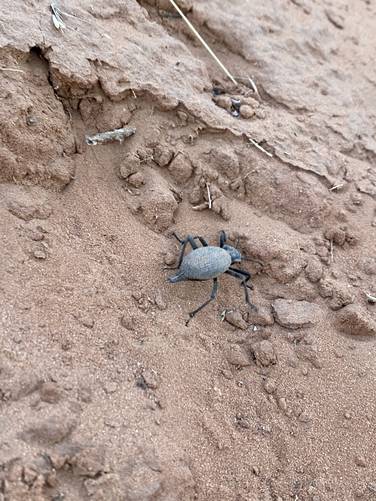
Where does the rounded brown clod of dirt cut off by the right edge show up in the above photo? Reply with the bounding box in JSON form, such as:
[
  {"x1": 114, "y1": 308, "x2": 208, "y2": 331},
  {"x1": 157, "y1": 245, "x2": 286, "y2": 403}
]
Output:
[{"x1": 335, "y1": 304, "x2": 376, "y2": 336}]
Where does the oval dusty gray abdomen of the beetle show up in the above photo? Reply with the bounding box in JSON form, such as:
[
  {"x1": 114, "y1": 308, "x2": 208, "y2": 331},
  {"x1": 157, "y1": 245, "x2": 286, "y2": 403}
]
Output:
[{"x1": 180, "y1": 246, "x2": 231, "y2": 280}]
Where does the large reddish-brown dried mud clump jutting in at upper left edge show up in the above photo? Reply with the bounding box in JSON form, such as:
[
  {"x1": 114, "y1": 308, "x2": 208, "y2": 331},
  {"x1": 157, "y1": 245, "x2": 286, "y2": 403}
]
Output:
[{"x1": 0, "y1": 55, "x2": 76, "y2": 189}]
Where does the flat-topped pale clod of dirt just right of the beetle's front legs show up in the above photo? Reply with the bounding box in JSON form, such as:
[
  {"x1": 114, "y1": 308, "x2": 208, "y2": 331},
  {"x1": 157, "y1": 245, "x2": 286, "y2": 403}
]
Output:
[{"x1": 272, "y1": 299, "x2": 321, "y2": 329}]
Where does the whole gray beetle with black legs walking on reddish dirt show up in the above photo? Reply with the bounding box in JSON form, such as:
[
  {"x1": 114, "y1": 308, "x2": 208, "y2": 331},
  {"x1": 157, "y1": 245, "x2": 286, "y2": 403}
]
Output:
[{"x1": 168, "y1": 231, "x2": 257, "y2": 325}]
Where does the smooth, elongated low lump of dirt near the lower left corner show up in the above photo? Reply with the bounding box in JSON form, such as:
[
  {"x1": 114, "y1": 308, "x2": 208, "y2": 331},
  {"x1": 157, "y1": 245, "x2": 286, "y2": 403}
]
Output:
[{"x1": 20, "y1": 412, "x2": 77, "y2": 444}]
